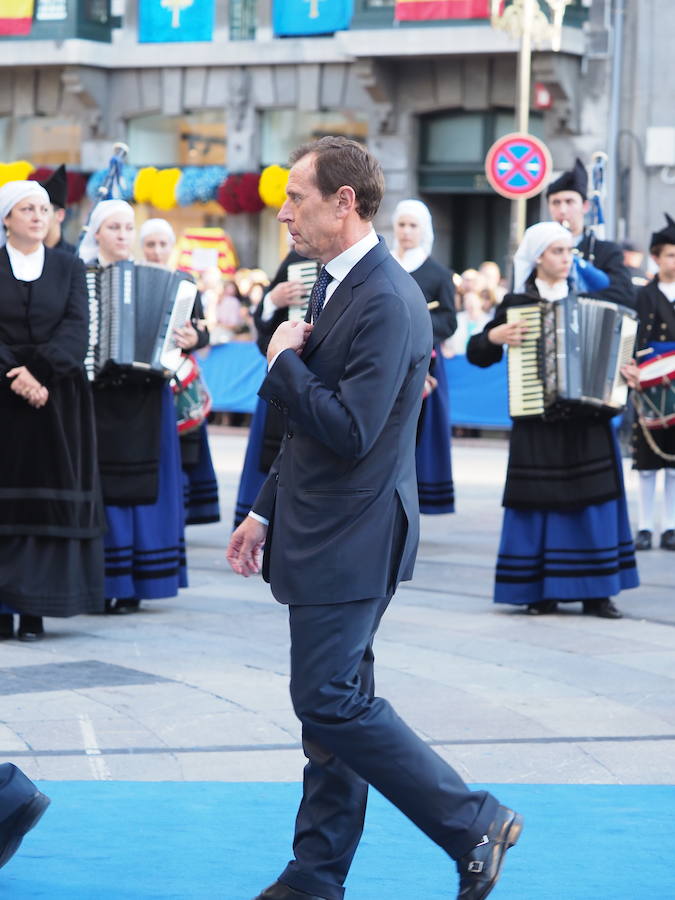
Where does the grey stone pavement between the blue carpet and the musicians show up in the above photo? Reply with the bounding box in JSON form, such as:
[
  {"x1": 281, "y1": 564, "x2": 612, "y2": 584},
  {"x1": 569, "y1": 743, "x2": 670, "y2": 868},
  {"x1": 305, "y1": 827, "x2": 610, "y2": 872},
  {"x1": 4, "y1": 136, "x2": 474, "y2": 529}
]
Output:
[{"x1": 0, "y1": 429, "x2": 675, "y2": 784}]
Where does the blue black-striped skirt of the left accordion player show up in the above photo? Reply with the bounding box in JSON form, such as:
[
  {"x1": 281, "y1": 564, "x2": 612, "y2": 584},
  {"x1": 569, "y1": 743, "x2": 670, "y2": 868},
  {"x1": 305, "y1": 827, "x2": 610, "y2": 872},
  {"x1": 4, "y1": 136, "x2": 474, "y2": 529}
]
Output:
[{"x1": 104, "y1": 385, "x2": 187, "y2": 600}]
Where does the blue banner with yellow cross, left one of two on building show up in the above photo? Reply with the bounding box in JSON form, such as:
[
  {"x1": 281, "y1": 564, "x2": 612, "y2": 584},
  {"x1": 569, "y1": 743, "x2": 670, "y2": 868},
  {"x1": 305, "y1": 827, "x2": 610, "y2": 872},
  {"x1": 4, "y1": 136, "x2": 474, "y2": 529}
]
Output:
[{"x1": 138, "y1": 0, "x2": 215, "y2": 44}]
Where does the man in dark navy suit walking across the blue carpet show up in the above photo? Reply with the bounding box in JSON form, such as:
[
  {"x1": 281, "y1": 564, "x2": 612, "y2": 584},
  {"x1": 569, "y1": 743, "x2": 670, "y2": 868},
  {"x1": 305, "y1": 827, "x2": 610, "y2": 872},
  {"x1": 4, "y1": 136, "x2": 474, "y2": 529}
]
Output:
[{"x1": 227, "y1": 137, "x2": 522, "y2": 900}]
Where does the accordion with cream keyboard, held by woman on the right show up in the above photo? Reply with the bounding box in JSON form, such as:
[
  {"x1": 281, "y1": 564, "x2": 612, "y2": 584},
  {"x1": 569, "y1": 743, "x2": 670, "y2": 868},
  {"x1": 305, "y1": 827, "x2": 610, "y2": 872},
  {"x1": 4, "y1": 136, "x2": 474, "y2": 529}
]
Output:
[{"x1": 506, "y1": 294, "x2": 638, "y2": 419}]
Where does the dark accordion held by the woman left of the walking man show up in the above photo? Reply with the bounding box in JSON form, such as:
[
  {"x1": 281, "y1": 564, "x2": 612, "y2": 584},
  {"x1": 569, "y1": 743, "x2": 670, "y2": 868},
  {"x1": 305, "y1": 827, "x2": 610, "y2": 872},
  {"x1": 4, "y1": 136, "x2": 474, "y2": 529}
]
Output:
[{"x1": 84, "y1": 260, "x2": 197, "y2": 381}]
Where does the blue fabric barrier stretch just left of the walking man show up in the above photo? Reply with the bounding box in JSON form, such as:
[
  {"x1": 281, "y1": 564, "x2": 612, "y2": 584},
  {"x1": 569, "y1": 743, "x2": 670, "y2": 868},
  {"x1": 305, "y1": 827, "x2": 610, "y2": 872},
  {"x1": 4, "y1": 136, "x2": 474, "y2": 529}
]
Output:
[{"x1": 199, "y1": 341, "x2": 267, "y2": 413}]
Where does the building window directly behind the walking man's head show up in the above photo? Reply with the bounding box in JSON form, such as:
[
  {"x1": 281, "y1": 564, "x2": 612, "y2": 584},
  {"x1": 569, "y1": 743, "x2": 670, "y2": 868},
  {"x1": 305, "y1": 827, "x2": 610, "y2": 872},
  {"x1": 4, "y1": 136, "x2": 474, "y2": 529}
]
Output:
[{"x1": 260, "y1": 109, "x2": 368, "y2": 166}]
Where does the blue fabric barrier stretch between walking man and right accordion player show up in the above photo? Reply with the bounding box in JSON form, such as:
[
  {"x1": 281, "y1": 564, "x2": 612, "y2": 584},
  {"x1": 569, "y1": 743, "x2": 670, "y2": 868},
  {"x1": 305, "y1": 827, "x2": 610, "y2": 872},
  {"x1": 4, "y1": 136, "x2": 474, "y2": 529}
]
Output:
[{"x1": 443, "y1": 356, "x2": 511, "y2": 428}]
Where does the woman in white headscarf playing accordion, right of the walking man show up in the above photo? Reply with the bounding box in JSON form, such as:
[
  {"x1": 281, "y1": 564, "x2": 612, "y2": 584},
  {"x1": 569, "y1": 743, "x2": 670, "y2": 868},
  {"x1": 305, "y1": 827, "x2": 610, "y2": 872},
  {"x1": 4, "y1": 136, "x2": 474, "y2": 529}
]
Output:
[{"x1": 467, "y1": 222, "x2": 639, "y2": 619}]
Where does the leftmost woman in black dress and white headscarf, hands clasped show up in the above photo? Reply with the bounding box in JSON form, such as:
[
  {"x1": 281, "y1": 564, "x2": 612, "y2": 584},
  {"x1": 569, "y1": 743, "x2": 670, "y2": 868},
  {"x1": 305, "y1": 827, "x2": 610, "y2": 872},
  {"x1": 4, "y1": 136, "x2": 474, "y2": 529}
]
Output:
[{"x1": 0, "y1": 181, "x2": 104, "y2": 641}]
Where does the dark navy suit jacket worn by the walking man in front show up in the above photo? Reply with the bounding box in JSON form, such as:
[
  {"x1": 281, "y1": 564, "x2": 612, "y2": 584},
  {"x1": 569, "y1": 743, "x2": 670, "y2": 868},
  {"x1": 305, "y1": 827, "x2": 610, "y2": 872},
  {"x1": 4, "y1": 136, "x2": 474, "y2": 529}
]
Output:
[{"x1": 253, "y1": 240, "x2": 432, "y2": 604}]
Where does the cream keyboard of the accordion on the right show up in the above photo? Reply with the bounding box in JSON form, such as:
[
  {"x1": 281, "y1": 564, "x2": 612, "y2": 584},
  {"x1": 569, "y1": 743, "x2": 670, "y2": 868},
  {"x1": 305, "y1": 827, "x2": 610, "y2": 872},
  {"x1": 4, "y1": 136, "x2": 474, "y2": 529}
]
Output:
[{"x1": 506, "y1": 303, "x2": 545, "y2": 418}]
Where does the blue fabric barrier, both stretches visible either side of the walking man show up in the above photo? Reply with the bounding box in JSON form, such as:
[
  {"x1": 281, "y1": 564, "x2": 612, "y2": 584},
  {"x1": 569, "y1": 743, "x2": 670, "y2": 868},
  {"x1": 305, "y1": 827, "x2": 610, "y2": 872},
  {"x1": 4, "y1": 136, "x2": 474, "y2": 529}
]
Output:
[{"x1": 199, "y1": 342, "x2": 511, "y2": 428}]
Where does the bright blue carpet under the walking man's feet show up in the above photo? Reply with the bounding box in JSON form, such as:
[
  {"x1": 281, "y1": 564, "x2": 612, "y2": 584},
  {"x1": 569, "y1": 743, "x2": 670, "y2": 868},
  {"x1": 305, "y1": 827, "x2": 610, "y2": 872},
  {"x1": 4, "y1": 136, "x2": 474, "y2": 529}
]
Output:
[{"x1": 5, "y1": 782, "x2": 675, "y2": 900}]
